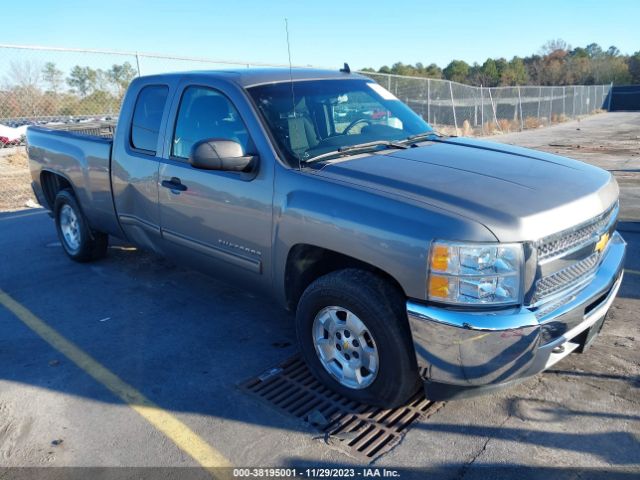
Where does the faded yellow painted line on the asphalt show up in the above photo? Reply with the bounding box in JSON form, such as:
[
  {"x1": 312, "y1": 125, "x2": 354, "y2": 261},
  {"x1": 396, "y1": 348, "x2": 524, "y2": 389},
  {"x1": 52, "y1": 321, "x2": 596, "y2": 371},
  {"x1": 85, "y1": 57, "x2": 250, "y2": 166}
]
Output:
[{"x1": 0, "y1": 290, "x2": 231, "y2": 468}]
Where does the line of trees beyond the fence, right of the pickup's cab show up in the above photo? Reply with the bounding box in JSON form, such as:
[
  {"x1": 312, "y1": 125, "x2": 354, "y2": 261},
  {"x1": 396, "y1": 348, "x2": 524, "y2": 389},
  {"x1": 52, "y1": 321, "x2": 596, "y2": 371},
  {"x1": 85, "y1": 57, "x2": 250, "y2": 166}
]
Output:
[{"x1": 363, "y1": 40, "x2": 640, "y2": 87}]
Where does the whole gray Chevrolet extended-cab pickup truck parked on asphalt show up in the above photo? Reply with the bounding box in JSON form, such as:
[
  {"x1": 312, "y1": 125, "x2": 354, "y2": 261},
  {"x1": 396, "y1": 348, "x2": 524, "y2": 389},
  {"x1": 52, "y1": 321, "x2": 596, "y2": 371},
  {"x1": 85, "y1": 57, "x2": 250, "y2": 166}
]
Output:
[{"x1": 27, "y1": 69, "x2": 625, "y2": 407}]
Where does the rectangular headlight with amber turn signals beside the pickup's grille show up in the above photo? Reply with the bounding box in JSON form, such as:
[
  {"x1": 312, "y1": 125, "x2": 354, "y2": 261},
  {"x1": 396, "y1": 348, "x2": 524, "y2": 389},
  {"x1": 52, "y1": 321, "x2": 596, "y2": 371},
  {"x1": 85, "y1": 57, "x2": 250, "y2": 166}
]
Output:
[{"x1": 427, "y1": 241, "x2": 524, "y2": 305}]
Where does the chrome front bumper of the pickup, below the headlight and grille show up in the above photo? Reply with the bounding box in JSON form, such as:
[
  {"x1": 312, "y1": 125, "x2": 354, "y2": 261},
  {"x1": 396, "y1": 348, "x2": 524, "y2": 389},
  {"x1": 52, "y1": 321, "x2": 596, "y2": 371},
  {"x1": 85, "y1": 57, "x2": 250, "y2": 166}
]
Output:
[{"x1": 407, "y1": 232, "x2": 626, "y2": 387}]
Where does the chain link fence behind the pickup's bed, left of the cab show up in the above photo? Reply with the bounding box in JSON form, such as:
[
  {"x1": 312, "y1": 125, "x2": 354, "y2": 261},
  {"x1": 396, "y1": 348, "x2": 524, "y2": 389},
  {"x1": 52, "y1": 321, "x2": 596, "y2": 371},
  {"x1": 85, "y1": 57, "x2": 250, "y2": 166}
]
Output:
[{"x1": 0, "y1": 45, "x2": 286, "y2": 212}]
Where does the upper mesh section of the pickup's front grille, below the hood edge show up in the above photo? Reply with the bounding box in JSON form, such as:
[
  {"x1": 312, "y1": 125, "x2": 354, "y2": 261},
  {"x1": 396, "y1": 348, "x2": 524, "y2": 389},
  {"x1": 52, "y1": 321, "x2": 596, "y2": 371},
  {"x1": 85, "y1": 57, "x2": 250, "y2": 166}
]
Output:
[{"x1": 536, "y1": 202, "x2": 618, "y2": 262}]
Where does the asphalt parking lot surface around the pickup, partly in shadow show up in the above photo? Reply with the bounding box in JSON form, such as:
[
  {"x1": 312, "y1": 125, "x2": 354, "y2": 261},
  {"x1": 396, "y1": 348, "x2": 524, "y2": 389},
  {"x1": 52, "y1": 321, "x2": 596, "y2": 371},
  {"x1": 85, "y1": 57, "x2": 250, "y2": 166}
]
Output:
[{"x1": 0, "y1": 113, "x2": 640, "y2": 479}]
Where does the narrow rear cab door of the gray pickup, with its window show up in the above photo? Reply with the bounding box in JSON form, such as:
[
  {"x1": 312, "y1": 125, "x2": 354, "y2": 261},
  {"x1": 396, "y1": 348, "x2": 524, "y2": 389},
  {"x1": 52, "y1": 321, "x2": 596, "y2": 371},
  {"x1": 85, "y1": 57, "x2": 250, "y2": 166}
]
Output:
[{"x1": 111, "y1": 81, "x2": 170, "y2": 250}]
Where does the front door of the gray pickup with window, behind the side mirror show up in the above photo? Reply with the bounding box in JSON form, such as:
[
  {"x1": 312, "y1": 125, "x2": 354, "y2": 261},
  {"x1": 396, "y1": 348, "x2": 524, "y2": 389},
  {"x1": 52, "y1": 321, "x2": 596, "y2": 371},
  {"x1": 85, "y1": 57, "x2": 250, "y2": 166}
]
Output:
[{"x1": 159, "y1": 80, "x2": 273, "y2": 287}]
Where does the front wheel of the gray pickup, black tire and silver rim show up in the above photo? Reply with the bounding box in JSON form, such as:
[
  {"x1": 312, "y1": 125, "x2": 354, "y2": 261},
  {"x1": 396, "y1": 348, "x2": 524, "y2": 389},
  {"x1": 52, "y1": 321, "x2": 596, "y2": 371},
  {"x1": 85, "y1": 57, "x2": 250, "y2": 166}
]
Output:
[{"x1": 296, "y1": 269, "x2": 420, "y2": 408}]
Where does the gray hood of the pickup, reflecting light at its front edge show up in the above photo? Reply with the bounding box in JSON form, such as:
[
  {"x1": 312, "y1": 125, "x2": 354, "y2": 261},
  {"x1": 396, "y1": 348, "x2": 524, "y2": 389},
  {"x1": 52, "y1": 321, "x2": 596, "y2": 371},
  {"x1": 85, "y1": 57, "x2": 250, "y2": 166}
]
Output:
[{"x1": 318, "y1": 138, "x2": 618, "y2": 242}]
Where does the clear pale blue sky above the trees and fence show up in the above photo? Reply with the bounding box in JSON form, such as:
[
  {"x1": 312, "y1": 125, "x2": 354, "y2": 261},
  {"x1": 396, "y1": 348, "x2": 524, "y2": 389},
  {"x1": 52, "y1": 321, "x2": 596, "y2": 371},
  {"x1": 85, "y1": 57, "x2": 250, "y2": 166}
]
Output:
[{"x1": 0, "y1": 0, "x2": 640, "y2": 69}]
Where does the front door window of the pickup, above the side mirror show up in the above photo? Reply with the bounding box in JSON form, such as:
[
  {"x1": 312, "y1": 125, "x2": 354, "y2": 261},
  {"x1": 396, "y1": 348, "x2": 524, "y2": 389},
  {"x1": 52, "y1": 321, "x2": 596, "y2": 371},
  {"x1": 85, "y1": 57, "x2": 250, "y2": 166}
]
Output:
[{"x1": 171, "y1": 87, "x2": 253, "y2": 158}]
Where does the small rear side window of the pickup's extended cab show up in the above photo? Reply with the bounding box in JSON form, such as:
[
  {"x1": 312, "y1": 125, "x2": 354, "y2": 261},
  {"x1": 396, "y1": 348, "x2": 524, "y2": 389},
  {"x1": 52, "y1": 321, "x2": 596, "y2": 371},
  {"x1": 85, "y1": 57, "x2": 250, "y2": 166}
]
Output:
[{"x1": 131, "y1": 85, "x2": 169, "y2": 155}]
